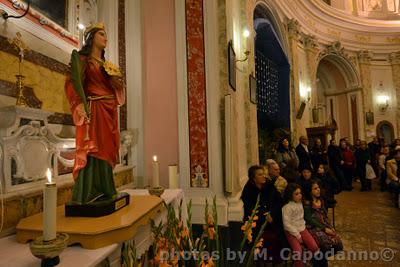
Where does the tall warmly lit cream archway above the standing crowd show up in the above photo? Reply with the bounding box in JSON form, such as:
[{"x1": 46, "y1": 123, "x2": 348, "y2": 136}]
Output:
[{"x1": 316, "y1": 52, "x2": 362, "y2": 142}]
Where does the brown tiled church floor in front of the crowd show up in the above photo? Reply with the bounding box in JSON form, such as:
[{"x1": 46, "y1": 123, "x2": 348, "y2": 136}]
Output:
[{"x1": 329, "y1": 181, "x2": 400, "y2": 267}]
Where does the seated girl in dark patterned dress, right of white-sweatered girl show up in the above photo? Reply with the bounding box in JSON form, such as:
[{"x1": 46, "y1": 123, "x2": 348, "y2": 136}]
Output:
[{"x1": 304, "y1": 180, "x2": 343, "y2": 254}]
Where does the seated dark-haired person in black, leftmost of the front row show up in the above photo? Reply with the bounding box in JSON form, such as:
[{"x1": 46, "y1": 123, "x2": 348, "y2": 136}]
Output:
[{"x1": 241, "y1": 165, "x2": 286, "y2": 263}]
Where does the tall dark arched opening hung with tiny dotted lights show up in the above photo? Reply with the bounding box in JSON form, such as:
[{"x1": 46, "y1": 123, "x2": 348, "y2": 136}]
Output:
[{"x1": 253, "y1": 4, "x2": 290, "y2": 163}]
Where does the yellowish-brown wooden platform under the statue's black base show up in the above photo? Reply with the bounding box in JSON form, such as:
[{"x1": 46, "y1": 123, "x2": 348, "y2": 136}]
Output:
[{"x1": 17, "y1": 195, "x2": 165, "y2": 249}]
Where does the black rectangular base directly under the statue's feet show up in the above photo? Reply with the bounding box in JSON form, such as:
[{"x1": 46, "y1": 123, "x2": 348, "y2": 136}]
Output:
[{"x1": 65, "y1": 192, "x2": 129, "y2": 217}]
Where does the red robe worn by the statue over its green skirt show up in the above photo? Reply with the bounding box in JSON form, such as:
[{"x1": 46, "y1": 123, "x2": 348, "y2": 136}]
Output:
[{"x1": 65, "y1": 56, "x2": 125, "y2": 179}]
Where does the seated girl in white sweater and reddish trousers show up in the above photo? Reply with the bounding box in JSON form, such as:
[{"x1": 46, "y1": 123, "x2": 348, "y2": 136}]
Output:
[{"x1": 282, "y1": 183, "x2": 319, "y2": 267}]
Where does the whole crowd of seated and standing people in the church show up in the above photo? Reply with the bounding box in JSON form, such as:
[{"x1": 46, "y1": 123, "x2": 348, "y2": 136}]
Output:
[{"x1": 241, "y1": 136, "x2": 400, "y2": 266}]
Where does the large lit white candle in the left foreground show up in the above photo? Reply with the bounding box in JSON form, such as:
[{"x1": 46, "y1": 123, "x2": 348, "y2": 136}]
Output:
[{"x1": 43, "y1": 169, "x2": 57, "y2": 241}]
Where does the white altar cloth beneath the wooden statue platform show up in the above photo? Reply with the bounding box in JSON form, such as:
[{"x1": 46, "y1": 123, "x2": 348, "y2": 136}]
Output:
[{"x1": 0, "y1": 189, "x2": 187, "y2": 267}]
